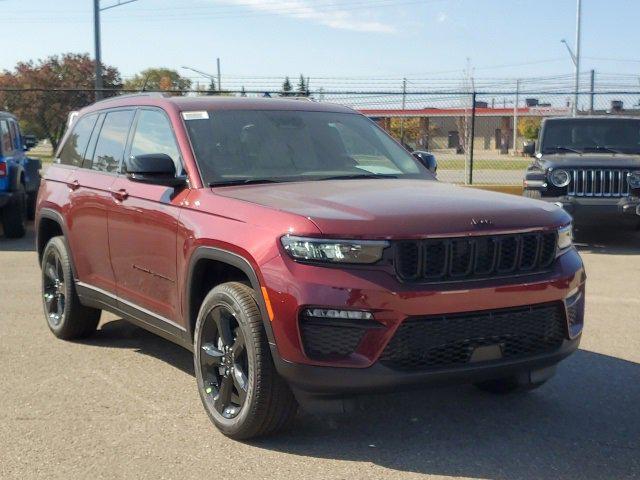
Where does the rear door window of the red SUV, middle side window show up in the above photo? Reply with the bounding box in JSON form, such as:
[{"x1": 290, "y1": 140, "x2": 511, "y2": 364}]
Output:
[{"x1": 88, "y1": 110, "x2": 134, "y2": 172}]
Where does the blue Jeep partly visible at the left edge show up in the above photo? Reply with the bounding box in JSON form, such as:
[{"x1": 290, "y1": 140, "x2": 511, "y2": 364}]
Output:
[{"x1": 0, "y1": 112, "x2": 42, "y2": 238}]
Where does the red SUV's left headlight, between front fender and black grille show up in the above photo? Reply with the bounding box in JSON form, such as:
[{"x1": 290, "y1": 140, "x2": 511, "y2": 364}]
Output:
[{"x1": 281, "y1": 235, "x2": 389, "y2": 263}]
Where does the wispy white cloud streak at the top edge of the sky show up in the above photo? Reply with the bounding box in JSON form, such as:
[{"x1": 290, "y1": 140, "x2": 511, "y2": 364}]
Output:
[{"x1": 215, "y1": 0, "x2": 395, "y2": 33}]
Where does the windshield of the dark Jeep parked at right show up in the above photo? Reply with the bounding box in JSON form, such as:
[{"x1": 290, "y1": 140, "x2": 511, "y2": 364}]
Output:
[{"x1": 541, "y1": 118, "x2": 640, "y2": 153}]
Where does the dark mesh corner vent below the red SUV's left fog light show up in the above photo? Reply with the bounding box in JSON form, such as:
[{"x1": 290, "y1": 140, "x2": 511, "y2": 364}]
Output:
[{"x1": 300, "y1": 316, "x2": 366, "y2": 360}]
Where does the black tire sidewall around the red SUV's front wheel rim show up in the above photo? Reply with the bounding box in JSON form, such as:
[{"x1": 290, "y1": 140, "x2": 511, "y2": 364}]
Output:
[{"x1": 194, "y1": 289, "x2": 260, "y2": 435}]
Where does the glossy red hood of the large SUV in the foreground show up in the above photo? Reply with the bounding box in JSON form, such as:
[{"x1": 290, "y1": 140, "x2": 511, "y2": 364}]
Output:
[{"x1": 214, "y1": 179, "x2": 571, "y2": 238}]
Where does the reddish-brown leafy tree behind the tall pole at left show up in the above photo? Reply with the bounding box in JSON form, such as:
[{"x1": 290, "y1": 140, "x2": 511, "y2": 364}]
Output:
[{"x1": 0, "y1": 53, "x2": 122, "y2": 149}]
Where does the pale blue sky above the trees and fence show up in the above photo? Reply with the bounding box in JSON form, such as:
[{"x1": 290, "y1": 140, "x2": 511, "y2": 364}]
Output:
[{"x1": 0, "y1": 0, "x2": 640, "y2": 87}]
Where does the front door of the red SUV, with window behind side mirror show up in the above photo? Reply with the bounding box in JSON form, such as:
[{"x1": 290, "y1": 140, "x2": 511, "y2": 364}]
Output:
[{"x1": 109, "y1": 107, "x2": 188, "y2": 329}]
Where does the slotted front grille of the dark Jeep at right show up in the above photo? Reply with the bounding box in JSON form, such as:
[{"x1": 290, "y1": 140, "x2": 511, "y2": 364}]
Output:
[{"x1": 567, "y1": 169, "x2": 629, "y2": 197}]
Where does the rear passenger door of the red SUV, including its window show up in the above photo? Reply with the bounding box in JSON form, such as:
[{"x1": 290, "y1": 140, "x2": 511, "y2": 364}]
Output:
[{"x1": 66, "y1": 109, "x2": 135, "y2": 295}]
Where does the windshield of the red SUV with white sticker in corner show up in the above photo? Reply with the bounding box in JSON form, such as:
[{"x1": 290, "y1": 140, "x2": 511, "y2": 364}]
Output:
[{"x1": 183, "y1": 110, "x2": 433, "y2": 185}]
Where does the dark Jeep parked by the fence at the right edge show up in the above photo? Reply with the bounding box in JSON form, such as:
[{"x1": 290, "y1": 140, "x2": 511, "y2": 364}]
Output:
[{"x1": 524, "y1": 116, "x2": 640, "y2": 226}]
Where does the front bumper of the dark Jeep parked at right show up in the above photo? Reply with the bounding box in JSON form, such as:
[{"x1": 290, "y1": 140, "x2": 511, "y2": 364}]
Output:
[{"x1": 542, "y1": 196, "x2": 640, "y2": 223}]
